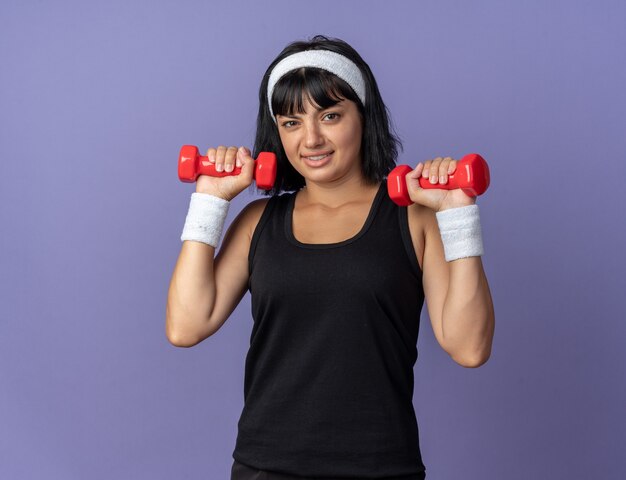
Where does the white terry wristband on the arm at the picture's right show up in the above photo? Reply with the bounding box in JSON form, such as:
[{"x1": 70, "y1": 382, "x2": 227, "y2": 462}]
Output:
[{"x1": 436, "y1": 204, "x2": 484, "y2": 262}]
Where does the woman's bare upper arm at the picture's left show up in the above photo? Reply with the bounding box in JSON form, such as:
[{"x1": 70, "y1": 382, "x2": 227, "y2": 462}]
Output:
[{"x1": 205, "y1": 198, "x2": 269, "y2": 338}]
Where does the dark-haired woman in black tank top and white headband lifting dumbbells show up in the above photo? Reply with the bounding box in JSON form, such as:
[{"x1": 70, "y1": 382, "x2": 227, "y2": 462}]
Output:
[{"x1": 166, "y1": 36, "x2": 494, "y2": 480}]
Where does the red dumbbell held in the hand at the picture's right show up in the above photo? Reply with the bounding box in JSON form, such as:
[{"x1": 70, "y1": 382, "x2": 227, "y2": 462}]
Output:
[{"x1": 387, "y1": 153, "x2": 489, "y2": 206}]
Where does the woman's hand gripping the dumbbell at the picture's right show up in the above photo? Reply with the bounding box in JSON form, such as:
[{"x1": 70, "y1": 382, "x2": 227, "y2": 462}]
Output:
[{"x1": 406, "y1": 157, "x2": 476, "y2": 212}]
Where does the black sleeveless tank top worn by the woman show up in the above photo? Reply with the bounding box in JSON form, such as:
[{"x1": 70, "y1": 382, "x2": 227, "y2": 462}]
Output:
[{"x1": 233, "y1": 182, "x2": 425, "y2": 480}]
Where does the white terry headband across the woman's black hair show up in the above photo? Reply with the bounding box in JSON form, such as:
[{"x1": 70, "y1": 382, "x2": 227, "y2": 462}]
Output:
[{"x1": 267, "y1": 50, "x2": 365, "y2": 123}]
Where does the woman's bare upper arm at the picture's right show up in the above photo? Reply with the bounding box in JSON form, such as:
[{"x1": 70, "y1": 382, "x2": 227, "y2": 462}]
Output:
[{"x1": 408, "y1": 204, "x2": 450, "y2": 352}]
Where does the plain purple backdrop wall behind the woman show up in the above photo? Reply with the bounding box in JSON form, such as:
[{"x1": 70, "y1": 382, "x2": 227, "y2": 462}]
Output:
[{"x1": 0, "y1": 0, "x2": 626, "y2": 480}]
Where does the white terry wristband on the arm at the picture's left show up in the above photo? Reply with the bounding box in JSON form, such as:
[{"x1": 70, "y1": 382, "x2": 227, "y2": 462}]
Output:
[{"x1": 180, "y1": 192, "x2": 230, "y2": 247}]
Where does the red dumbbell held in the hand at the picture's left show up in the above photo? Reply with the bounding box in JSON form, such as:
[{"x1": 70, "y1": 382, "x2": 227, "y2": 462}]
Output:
[{"x1": 178, "y1": 145, "x2": 276, "y2": 190}]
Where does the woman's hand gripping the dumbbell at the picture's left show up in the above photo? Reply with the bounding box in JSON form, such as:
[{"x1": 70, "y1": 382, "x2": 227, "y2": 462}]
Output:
[{"x1": 196, "y1": 145, "x2": 255, "y2": 201}]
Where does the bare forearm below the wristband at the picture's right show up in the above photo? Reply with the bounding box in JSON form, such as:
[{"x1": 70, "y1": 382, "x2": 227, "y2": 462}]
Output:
[{"x1": 442, "y1": 256, "x2": 495, "y2": 366}]
